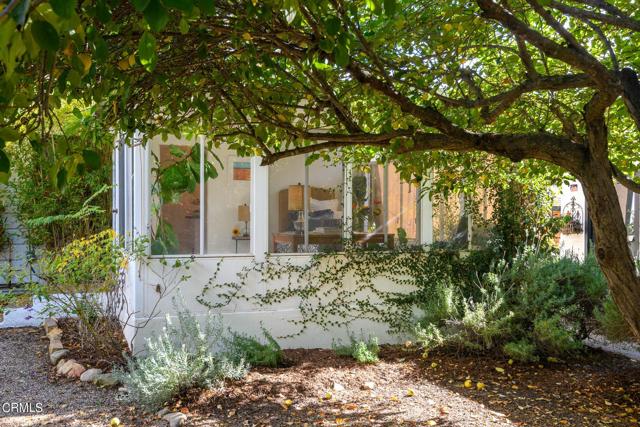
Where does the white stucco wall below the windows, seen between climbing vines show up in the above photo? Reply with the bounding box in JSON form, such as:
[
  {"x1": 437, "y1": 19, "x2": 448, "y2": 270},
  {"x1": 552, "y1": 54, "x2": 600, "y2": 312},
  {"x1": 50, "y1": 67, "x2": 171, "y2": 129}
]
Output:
[{"x1": 126, "y1": 256, "x2": 410, "y2": 352}]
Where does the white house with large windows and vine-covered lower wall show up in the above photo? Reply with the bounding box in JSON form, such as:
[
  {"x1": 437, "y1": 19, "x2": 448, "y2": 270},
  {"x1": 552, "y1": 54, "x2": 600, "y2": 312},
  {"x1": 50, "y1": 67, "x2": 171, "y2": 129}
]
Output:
[{"x1": 113, "y1": 137, "x2": 432, "y2": 351}]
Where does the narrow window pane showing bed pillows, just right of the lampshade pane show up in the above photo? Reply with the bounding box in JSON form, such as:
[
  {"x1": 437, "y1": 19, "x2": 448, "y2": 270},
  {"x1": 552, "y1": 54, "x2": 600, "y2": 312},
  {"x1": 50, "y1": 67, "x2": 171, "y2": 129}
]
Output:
[{"x1": 306, "y1": 160, "x2": 344, "y2": 252}]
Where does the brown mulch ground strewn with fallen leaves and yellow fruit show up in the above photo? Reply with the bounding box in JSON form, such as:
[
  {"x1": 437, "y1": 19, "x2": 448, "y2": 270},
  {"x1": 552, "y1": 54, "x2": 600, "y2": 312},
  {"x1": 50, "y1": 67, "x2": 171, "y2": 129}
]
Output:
[{"x1": 176, "y1": 346, "x2": 640, "y2": 427}]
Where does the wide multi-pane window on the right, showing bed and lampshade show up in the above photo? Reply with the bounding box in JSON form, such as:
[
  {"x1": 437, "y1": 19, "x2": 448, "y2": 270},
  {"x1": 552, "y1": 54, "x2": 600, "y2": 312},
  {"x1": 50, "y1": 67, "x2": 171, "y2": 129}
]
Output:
[{"x1": 269, "y1": 156, "x2": 419, "y2": 253}]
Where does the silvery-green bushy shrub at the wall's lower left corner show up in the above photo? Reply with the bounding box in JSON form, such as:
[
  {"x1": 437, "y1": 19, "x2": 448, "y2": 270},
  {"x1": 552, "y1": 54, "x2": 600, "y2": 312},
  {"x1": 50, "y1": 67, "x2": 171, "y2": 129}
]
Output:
[{"x1": 117, "y1": 300, "x2": 247, "y2": 410}]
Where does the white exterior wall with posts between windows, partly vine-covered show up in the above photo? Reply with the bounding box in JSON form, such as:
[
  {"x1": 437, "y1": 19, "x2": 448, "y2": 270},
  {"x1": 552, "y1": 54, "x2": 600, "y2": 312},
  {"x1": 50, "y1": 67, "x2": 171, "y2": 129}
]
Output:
[{"x1": 114, "y1": 135, "x2": 432, "y2": 352}]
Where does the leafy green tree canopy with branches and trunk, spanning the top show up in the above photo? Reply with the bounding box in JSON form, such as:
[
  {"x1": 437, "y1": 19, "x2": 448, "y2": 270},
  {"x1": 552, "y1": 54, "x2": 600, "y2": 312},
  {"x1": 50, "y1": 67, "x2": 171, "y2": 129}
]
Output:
[{"x1": 0, "y1": 0, "x2": 640, "y2": 336}]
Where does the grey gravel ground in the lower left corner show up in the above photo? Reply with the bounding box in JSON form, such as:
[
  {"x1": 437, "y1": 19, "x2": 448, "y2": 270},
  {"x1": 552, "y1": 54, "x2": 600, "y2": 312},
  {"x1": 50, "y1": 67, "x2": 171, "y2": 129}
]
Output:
[{"x1": 0, "y1": 328, "x2": 157, "y2": 427}]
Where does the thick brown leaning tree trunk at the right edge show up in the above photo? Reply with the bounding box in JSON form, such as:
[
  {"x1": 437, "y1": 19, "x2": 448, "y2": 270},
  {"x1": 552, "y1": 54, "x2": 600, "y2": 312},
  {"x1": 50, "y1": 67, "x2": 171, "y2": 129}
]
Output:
[{"x1": 580, "y1": 161, "x2": 640, "y2": 339}]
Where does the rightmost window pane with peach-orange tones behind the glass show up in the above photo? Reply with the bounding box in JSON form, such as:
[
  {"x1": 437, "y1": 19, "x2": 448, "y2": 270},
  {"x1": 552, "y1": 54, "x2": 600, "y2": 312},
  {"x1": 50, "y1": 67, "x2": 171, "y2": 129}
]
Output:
[{"x1": 387, "y1": 165, "x2": 419, "y2": 245}]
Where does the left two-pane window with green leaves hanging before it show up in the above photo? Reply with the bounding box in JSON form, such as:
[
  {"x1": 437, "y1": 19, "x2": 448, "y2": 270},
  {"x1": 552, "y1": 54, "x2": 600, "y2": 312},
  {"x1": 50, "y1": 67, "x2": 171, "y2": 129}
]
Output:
[{"x1": 151, "y1": 138, "x2": 251, "y2": 255}]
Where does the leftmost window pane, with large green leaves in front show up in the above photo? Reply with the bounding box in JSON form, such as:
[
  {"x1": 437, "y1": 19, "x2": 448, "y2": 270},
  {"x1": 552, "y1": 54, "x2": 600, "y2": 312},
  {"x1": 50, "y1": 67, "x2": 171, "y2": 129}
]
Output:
[{"x1": 151, "y1": 137, "x2": 200, "y2": 255}]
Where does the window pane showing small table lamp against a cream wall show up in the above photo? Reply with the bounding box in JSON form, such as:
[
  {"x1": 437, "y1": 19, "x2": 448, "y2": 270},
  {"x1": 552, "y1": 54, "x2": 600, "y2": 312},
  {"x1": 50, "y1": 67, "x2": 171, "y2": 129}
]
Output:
[{"x1": 205, "y1": 148, "x2": 251, "y2": 254}]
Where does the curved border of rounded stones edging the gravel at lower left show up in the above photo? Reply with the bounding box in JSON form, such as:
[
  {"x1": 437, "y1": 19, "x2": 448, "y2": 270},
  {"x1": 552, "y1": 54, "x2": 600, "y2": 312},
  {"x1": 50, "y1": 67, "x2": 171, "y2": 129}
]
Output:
[{"x1": 42, "y1": 317, "x2": 187, "y2": 427}]
